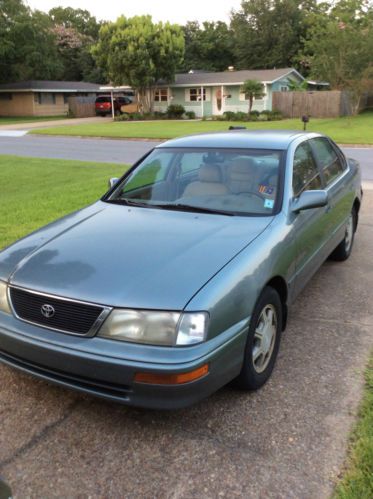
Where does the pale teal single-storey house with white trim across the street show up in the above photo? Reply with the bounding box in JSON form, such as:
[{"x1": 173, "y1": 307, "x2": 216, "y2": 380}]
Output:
[{"x1": 153, "y1": 68, "x2": 304, "y2": 117}]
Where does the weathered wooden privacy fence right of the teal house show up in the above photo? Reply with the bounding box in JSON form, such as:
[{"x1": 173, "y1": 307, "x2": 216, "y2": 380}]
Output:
[{"x1": 272, "y1": 90, "x2": 342, "y2": 118}]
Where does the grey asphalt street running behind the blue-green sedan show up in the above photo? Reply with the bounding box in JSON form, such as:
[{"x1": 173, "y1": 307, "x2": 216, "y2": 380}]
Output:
[{"x1": 0, "y1": 135, "x2": 373, "y2": 181}]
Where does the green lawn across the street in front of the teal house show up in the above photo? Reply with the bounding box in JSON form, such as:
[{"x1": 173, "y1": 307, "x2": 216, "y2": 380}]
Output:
[{"x1": 31, "y1": 113, "x2": 373, "y2": 144}]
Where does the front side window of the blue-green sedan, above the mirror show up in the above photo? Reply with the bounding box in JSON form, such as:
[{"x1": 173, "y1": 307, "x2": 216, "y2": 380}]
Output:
[{"x1": 293, "y1": 142, "x2": 322, "y2": 196}]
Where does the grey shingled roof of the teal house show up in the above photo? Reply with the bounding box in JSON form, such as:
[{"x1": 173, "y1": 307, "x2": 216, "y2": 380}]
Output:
[{"x1": 162, "y1": 68, "x2": 302, "y2": 86}]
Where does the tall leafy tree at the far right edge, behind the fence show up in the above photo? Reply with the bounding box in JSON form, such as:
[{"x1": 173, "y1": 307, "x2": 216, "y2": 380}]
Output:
[{"x1": 299, "y1": 0, "x2": 373, "y2": 113}]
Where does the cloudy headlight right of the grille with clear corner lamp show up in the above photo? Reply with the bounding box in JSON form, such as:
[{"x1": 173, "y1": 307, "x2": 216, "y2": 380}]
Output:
[{"x1": 98, "y1": 309, "x2": 208, "y2": 346}]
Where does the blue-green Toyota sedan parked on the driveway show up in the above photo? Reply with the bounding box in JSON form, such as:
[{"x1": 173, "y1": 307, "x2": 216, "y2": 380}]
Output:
[{"x1": 0, "y1": 130, "x2": 362, "y2": 408}]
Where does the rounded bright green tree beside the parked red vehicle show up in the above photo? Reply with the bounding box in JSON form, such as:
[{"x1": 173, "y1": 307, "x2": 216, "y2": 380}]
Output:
[{"x1": 92, "y1": 16, "x2": 184, "y2": 111}]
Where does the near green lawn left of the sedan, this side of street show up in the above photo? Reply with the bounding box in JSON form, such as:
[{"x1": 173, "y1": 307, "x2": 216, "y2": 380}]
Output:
[{"x1": 0, "y1": 156, "x2": 126, "y2": 248}]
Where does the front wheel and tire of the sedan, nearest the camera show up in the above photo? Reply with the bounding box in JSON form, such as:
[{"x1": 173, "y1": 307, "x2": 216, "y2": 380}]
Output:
[{"x1": 235, "y1": 286, "x2": 283, "y2": 390}]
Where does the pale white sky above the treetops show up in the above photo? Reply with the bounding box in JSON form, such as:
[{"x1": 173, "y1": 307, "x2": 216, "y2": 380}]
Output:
[{"x1": 25, "y1": 0, "x2": 241, "y2": 24}]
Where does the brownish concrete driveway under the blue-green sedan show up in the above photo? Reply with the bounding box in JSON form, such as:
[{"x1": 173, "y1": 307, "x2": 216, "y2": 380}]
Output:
[{"x1": 0, "y1": 189, "x2": 373, "y2": 499}]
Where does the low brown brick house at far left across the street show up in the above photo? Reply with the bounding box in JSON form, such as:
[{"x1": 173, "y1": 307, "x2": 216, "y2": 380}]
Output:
[{"x1": 0, "y1": 80, "x2": 101, "y2": 116}]
